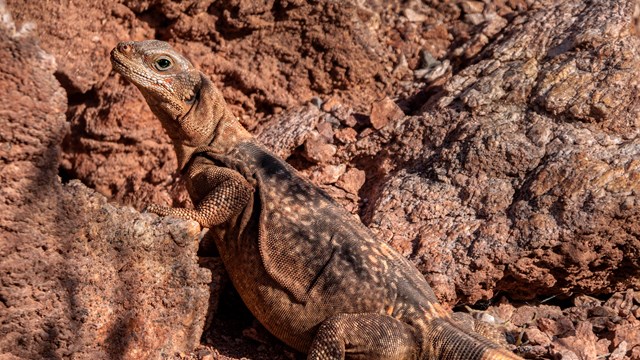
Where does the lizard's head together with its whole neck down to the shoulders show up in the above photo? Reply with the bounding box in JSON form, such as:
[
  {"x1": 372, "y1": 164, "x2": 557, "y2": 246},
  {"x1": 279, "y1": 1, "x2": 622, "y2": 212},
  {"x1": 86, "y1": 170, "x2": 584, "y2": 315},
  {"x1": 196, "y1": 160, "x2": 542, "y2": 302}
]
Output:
[{"x1": 110, "y1": 40, "x2": 251, "y2": 169}]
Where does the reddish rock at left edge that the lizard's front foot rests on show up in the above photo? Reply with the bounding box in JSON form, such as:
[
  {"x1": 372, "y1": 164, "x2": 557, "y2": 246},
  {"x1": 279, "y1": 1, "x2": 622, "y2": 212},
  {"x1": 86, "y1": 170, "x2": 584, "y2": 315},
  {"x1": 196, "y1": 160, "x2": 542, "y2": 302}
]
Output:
[{"x1": 0, "y1": 8, "x2": 211, "y2": 359}]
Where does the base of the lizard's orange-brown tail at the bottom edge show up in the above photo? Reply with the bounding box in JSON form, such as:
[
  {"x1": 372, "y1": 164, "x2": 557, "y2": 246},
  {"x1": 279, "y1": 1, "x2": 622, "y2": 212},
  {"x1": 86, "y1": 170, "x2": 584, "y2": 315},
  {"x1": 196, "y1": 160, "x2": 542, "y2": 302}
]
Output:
[{"x1": 423, "y1": 318, "x2": 522, "y2": 360}]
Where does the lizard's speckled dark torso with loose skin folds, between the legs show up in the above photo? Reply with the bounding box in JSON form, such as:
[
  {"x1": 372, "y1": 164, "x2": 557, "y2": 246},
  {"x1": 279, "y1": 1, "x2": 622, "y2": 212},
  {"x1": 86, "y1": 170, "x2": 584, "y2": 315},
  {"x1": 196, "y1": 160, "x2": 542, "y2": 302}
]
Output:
[{"x1": 201, "y1": 142, "x2": 437, "y2": 351}]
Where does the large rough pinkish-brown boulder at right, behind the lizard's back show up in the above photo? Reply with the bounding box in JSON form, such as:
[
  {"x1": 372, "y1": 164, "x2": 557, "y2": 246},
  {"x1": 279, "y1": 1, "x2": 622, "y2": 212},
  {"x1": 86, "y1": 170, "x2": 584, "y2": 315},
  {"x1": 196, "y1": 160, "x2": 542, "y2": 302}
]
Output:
[{"x1": 366, "y1": 1, "x2": 640, "y2": 302}]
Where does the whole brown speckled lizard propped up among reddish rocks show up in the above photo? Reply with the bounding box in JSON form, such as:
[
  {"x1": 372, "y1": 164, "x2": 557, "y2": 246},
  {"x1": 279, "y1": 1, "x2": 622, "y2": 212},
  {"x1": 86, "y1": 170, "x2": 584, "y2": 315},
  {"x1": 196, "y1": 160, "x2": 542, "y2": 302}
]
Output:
[{"x1": 111, "y1": 40, "x2": 521, "y2": 360}]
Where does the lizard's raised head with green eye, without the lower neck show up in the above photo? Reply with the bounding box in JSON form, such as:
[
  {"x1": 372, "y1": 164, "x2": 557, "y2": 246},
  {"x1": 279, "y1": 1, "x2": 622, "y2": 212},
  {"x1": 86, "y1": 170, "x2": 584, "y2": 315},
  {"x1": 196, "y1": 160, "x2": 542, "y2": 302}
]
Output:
[{"x1": 111, "y1": 40, "x2": 224, "y2": 147}]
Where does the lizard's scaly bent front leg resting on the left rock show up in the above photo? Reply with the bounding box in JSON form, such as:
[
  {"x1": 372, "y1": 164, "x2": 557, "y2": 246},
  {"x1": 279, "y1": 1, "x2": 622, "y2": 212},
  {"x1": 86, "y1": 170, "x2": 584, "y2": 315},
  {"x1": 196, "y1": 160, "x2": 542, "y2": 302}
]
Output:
[{"x1": 147, "y1": 164, "x2": 253, "y2": 228}]
